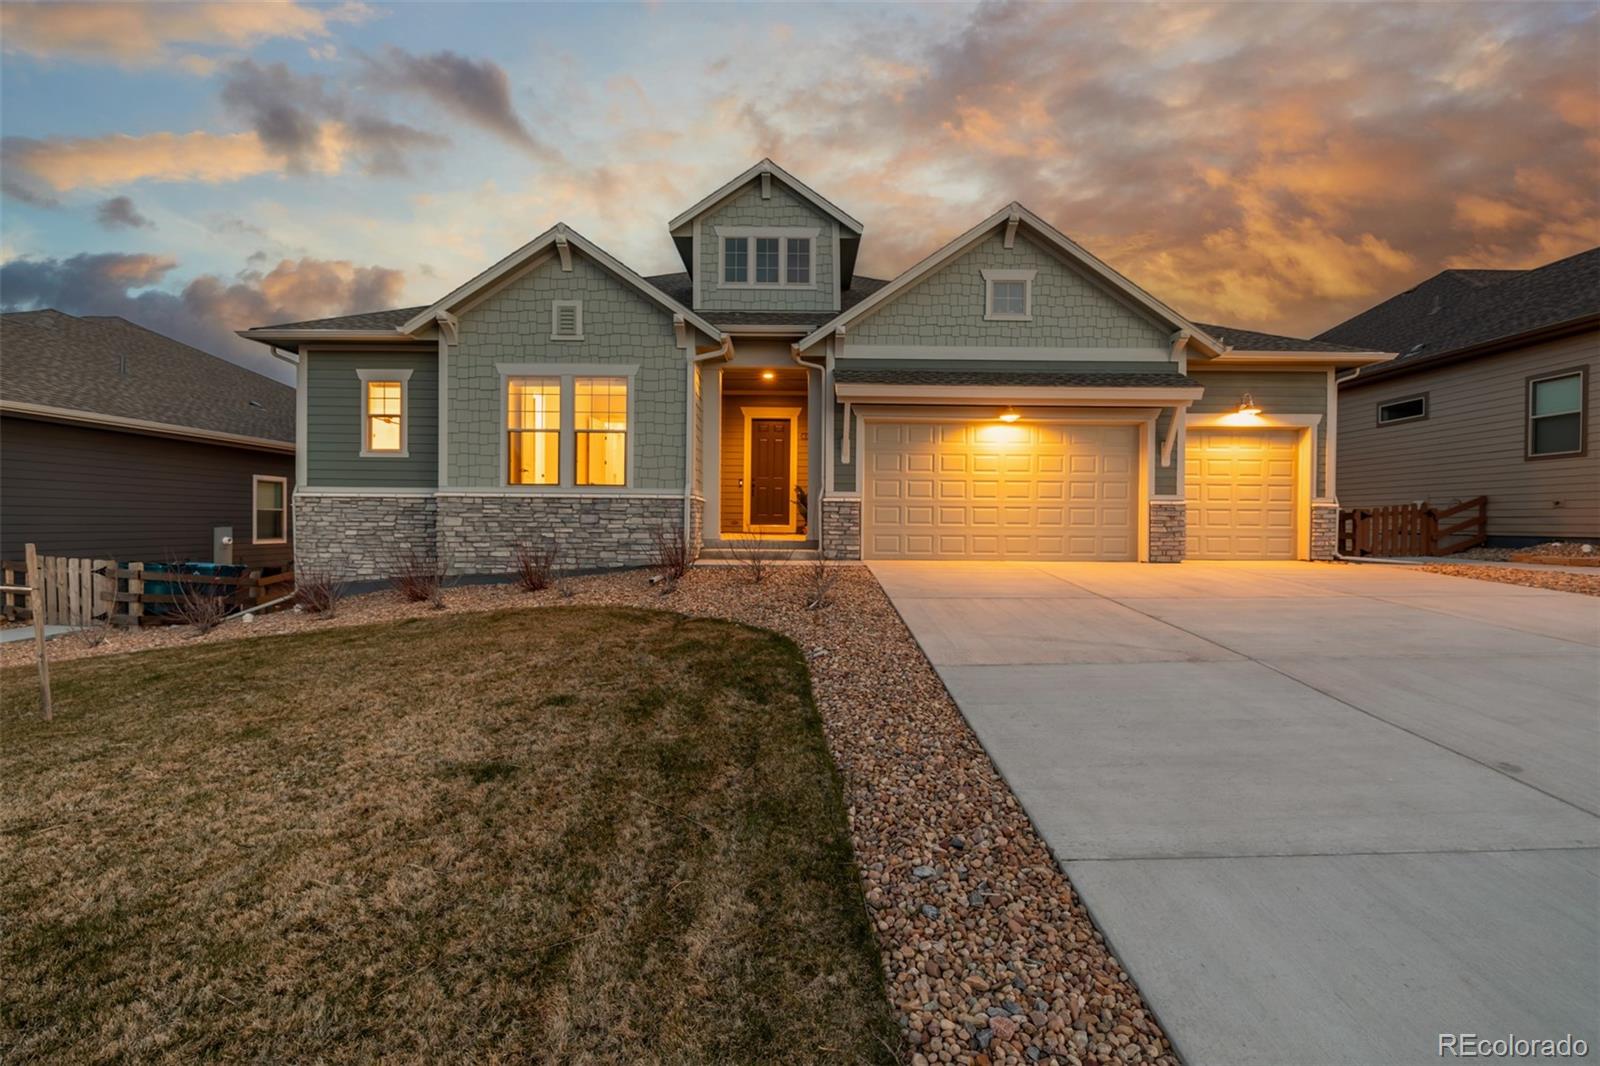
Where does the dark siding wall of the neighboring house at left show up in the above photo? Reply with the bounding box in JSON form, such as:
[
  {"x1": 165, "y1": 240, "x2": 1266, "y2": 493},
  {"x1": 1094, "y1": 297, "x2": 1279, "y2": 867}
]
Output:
[{"x1": 0, "y1": 416, "x2": 294, "y2": 567}]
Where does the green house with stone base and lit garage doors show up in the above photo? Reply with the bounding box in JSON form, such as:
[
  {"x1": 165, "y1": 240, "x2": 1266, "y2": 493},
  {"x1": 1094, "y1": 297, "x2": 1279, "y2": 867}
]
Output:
[{"x1": 242, "y1": 160, "x2": 1387, "y2": 578}]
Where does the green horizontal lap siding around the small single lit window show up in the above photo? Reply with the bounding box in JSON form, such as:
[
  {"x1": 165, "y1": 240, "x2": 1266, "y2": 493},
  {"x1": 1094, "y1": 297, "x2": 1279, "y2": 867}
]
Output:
[{"x1": 306, "y1": 351, "x2": 438, "y2": 488}]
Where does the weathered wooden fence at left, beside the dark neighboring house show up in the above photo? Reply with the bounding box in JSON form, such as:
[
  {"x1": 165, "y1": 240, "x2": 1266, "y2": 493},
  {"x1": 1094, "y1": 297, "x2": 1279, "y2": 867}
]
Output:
[{"x1": 0, "y1": 555, "x2": 294, "y2": 626}]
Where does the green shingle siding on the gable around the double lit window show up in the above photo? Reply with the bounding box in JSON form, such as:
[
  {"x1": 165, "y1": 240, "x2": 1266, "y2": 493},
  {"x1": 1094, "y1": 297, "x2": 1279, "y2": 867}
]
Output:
[{"x1": 448, "y1": 248, "x2": 688, "y2": 491}]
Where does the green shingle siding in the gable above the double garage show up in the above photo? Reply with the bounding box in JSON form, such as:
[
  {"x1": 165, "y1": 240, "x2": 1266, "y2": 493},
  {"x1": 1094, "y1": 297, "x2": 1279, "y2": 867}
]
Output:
[{"x1": 850, "y1": 230, "x2": 1173, "y2": 347}]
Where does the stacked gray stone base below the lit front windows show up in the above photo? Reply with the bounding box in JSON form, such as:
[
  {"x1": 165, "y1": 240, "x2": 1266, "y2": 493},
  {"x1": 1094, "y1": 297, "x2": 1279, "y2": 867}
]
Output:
[{"x1": 294, "y1": 493, "x2": 699, "y2": 581}]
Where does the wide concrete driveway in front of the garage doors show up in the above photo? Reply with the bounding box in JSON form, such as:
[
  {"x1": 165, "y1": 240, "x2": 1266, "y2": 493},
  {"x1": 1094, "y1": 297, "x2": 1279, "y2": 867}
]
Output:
[{"x1": 872, "y1": 562, "x2": 1600, "y2": 1066}]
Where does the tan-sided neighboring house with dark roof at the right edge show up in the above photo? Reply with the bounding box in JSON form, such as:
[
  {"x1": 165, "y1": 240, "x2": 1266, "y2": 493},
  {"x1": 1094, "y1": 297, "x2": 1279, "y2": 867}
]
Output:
[{"x1": 1318, "y1": 248, "x2": 1600, "y2": 544}]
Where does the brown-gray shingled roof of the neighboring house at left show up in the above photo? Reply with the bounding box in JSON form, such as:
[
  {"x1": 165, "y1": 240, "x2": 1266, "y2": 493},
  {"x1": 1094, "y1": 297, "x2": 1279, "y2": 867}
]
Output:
[{"x1": 0, "y1": 309, "x2": 294, "y2": 448}]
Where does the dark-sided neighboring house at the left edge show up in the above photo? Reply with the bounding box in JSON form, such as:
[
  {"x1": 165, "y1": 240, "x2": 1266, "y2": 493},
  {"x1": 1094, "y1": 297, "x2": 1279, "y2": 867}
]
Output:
[{"x1": 0, "y1": 311, "x2": 294, "y2": 567}]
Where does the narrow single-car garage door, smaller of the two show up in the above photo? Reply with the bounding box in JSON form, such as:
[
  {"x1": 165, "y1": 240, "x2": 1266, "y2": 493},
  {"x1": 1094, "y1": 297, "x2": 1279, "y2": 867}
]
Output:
[{"x1": 1184, "y1": 429, "x2": 1299, "y2": 559}]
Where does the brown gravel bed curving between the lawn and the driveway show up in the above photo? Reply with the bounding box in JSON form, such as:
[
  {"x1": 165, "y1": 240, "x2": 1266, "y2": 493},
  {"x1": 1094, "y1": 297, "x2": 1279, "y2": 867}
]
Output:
[{"x1": 0, "y1": 567, "x2": 1178, "y2": 1066}]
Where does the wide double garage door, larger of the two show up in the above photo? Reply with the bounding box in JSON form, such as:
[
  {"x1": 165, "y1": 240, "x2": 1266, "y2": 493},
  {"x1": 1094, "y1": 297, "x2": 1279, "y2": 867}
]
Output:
[{"x1": 862, "y1": 423, "x2": 1139, "y2": 560}]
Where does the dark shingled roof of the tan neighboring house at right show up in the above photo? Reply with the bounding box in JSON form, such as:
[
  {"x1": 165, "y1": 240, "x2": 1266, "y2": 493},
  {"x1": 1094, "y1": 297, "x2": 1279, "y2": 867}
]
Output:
[{"x1": 1317, "y1": 248, "x2": 1600, "y2": 379}]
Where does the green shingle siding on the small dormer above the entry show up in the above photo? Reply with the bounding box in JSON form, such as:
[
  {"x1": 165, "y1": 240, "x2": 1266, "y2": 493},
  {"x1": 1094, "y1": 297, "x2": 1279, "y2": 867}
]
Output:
[{"x1": 699, "y1": 178, "x2": 835, "y2": 311}]
